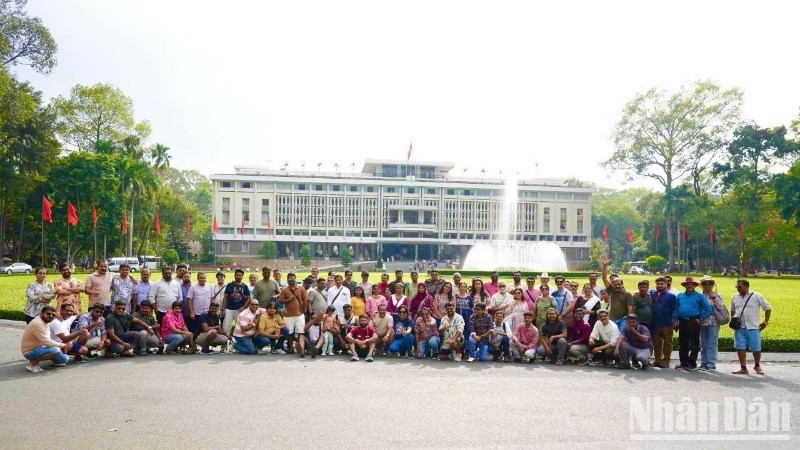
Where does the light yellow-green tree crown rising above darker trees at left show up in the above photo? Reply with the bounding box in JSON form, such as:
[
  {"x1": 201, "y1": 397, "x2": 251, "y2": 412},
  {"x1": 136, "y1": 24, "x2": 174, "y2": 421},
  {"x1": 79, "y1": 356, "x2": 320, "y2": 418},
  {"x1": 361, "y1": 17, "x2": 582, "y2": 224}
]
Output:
[{"x1": 53, "y1": 83, "x2": 150, "y2": 150}]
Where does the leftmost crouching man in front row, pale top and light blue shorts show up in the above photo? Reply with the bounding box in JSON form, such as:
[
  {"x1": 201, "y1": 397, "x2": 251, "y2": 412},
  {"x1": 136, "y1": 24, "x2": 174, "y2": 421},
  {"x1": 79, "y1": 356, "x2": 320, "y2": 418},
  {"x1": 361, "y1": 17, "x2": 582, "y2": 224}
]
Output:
[{"x1": 20, "y1": 305, "x2": 71, "y2": 373}]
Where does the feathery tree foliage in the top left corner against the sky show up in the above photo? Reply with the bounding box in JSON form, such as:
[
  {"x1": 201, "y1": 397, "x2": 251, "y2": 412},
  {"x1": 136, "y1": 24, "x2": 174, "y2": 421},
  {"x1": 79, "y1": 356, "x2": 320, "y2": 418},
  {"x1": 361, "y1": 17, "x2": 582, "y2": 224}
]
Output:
[{"x1": 0, "y1": 0, "x2": 58, "y2": 75}]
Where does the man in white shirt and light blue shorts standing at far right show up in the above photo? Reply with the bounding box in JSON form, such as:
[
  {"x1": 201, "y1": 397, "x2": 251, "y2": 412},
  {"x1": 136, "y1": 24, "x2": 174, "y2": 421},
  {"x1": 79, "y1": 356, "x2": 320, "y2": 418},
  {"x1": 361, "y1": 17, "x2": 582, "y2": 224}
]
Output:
[{"x1": 731, "y1": 278, "x2": 772, "y2": 375}]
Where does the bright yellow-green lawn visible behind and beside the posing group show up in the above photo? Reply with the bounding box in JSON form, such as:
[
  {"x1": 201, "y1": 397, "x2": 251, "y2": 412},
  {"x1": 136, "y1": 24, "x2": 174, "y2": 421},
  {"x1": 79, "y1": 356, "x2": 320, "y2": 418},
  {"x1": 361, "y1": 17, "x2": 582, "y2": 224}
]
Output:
[{"x1": 0, "y1": 272, "x2": 800, "y2": 351}]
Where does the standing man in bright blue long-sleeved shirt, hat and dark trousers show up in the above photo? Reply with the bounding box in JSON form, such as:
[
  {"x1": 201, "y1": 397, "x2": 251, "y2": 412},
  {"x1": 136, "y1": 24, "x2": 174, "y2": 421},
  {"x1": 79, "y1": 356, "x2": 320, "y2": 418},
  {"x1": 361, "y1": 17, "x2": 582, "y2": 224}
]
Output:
[{"x1": 674, "y1": 277, "x2": 712, "y2": 370}]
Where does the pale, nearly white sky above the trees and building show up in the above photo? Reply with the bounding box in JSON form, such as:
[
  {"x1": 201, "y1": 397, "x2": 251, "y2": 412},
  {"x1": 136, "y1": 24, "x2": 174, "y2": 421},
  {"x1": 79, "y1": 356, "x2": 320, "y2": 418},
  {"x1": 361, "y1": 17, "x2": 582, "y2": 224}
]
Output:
[{"x1": 17, "y1": 0, "x2": 800, "y2": 188}]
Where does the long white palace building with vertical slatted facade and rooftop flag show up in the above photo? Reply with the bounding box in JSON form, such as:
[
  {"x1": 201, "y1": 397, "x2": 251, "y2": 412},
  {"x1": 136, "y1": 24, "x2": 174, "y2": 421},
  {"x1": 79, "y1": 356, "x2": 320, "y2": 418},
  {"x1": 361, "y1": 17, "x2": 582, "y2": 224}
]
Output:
[{"x1": 211, "y1": 160, "x2": 593, "y2": 267}]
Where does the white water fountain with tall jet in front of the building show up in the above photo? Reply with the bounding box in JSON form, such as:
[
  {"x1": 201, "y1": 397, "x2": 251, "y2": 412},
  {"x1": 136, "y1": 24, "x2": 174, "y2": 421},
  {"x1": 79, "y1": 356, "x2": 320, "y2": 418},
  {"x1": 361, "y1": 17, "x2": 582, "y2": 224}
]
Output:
[{"x1": 462, "y1": 174, "x2": 567, "y2": 272}]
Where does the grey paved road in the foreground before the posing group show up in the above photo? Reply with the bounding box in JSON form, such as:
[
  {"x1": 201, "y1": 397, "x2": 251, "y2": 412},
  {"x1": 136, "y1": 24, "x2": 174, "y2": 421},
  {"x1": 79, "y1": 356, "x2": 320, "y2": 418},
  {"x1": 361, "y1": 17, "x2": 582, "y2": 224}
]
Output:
[{"x1": 0, "y1": 327, "x2": 800, "y2": 448}]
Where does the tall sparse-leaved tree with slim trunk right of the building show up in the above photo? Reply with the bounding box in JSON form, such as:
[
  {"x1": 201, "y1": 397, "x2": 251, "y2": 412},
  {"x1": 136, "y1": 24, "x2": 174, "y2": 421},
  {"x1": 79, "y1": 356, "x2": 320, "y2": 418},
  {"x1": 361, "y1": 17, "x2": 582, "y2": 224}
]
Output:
[{"x1": 603, "y1": 81, "x2": 742, "y2": 271}]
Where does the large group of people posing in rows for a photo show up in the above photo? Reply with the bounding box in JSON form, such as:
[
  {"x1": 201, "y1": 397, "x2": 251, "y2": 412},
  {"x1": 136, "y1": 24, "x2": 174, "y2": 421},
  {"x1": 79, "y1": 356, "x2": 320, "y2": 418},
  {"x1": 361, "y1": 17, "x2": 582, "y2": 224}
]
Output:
[{"x1": 21, "y1": 258, "x2": 772, "y2": 374}]
